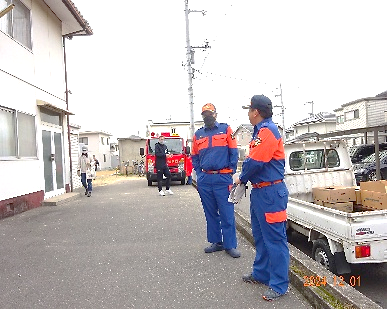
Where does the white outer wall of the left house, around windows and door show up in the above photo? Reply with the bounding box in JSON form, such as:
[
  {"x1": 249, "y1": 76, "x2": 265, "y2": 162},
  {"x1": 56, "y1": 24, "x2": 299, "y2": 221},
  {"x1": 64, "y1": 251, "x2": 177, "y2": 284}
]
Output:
[{"x1": 0, "y1": 0, "x2": 70, "y2": 214}]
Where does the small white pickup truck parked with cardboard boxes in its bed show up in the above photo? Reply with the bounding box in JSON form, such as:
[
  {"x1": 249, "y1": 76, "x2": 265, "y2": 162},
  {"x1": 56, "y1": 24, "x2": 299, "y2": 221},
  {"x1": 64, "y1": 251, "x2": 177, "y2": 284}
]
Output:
[{"x1": 285, "y1": 139, "x2": 387, "y2": 274}]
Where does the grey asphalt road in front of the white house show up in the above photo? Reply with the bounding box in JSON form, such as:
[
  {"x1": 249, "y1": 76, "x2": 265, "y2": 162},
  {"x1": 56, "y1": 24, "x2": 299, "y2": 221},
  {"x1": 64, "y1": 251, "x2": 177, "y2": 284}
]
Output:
[{"x1": 0, "y1": 178, "x2": 311, "y2": 309}]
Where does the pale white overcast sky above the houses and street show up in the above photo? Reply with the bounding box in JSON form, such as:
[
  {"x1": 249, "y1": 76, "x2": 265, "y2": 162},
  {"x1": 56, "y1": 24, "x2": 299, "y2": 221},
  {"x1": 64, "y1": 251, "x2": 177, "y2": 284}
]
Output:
[{"x1": 66, "y1": 0, "x2": 387, "y2": 138}]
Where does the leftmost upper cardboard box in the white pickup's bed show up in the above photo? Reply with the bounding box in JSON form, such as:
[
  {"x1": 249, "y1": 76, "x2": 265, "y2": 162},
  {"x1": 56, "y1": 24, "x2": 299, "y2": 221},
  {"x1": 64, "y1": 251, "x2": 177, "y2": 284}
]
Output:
[{"x1": 312, "y1": 186, "x2": 356, "y2": 203}]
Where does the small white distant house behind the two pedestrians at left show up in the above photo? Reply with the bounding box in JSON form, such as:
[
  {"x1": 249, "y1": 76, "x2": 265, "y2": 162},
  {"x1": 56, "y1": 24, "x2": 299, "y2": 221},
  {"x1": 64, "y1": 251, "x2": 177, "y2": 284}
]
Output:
[{"x1": 79, "y1": 131, "x2": 115, "y2": 170}]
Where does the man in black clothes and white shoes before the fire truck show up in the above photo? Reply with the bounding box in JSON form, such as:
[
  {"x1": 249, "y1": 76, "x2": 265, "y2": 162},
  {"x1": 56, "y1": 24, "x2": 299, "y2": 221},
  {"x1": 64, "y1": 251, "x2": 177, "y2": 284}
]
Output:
[{"x1": 155, "y1": 135, "x2": 173, "y2": 196}]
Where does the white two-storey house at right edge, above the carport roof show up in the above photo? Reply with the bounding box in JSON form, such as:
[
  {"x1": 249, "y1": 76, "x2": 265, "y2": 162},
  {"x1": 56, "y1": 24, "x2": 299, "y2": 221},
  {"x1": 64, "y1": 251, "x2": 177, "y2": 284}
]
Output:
[{"x1": 334, "y1": 91, "x2": 387, "y2": 146}]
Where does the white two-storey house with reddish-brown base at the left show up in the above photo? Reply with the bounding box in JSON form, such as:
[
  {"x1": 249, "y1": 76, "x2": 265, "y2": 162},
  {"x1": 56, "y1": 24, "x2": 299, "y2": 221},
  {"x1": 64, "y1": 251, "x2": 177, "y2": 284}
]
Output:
[{"x1": 0, "y1": 0, "x2": 93, "y2": 218}]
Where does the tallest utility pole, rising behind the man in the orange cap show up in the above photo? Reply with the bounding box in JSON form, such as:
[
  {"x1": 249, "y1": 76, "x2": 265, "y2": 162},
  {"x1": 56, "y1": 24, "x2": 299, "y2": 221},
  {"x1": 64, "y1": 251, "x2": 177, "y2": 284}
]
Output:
[{"x1": 184, "y1": 0, "x2": 210, "y2": 142}]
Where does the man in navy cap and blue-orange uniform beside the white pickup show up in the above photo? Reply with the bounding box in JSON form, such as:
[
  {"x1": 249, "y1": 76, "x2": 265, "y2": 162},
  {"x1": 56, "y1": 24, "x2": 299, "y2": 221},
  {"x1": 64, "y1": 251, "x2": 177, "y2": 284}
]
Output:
[{"x1": 235, "y1": 95, "x2": 290, "y2": 301}]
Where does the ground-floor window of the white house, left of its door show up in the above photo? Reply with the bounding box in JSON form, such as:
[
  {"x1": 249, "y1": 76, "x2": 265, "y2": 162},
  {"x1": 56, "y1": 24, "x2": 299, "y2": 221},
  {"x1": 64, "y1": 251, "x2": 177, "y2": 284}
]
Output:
[{"x1": 0, "y1": 106, "x2": 37, "y2": 158}]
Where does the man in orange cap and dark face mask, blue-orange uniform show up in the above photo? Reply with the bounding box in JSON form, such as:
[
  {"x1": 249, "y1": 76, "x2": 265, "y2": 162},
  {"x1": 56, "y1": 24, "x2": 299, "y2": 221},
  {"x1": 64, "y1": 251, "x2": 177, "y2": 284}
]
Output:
[{"x1": 192, "y1": 103, "x2": 241, "y2": 258}]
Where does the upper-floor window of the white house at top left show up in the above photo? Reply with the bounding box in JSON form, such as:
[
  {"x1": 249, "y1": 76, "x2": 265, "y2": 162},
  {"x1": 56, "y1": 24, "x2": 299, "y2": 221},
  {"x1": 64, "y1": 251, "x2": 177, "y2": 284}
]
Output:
[{"x1": 0, "y1": 0, "x2": 32, "y2": 49}]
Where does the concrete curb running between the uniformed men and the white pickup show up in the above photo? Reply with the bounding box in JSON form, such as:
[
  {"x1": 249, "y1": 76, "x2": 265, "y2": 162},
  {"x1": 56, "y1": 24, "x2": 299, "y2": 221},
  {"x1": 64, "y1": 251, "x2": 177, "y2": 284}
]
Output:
[{"x1": 235, "y1": 210, "x2": 382, "y2": 309}]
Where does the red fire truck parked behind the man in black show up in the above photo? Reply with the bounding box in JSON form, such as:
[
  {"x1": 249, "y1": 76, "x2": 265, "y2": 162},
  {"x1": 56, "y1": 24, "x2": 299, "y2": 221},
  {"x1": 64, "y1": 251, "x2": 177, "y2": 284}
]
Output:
[{"x1": 140, "y1": 132, "x2": 190, "y2": 186}]
